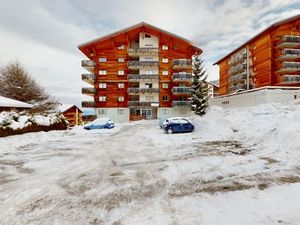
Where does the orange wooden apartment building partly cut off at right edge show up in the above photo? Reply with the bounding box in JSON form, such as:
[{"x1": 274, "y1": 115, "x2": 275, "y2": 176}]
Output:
[{"x1": 215, "y1": 15, "x2": 300, "y2": 95}]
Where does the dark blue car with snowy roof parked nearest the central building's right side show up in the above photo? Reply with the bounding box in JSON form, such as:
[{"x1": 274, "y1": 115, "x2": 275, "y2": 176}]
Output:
[{"x1": 163, "y1": 117, "x2": 195, "y2": 134}]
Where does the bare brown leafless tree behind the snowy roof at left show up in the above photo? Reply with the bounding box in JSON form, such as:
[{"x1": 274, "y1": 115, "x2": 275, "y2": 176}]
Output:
[{"x1": 0, "y1": 61, "x2": 59, "y2": 111}]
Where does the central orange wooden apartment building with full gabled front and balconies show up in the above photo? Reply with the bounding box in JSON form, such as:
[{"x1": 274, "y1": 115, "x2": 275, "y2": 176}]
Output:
[{"x1": 78, "y1": 22, "x2": 202, "y2": 122}]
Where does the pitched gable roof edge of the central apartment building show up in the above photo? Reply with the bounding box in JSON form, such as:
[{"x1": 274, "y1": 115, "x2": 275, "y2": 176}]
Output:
[{"x1": 78, "y1": 22, "x2": 202, "y2": 53}]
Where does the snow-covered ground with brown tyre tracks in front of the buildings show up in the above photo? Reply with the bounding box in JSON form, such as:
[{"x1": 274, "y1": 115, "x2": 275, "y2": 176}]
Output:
[{"x1": 0, "y1": 102, "x2": 300, "y2": 225}]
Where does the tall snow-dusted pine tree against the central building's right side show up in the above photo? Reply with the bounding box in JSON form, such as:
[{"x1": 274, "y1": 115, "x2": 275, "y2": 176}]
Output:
[{"x1": 191, "y1": 55, "x2": 208, "y2": 116}]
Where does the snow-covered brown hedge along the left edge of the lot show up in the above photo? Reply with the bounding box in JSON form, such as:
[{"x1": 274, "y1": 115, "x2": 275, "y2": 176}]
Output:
[{"x1": 0, "y1": 111, "x2": 68, "y2": 137}]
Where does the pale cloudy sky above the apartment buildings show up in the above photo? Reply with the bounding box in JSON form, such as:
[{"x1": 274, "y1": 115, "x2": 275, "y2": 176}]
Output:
[{"x1": 0, "y1": 0, "x2": 300, "y2": 106}]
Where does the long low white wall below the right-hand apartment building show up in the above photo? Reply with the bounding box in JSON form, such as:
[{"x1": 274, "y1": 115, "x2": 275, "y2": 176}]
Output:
[{"x1": 209, "y1": 86, "x2": 300, "y2": 108}]
